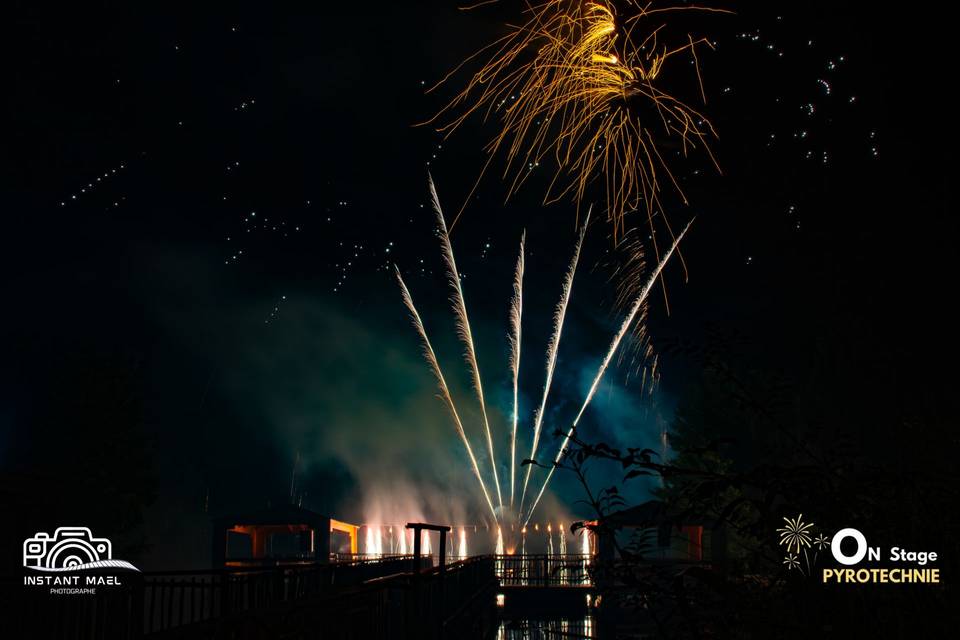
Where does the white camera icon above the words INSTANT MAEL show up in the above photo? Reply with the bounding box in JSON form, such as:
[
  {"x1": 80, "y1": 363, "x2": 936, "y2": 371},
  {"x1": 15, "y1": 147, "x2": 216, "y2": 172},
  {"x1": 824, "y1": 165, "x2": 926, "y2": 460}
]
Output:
[{"x1": 23, "y1": 527, "x2": 137, "y2": 571}]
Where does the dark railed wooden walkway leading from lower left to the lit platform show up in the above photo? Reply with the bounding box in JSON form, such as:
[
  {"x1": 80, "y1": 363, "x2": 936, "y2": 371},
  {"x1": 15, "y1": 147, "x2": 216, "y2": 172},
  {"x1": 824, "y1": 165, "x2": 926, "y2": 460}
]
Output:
[{"x1": 7, "y1": 555, "x2": 592, "y2": 640}]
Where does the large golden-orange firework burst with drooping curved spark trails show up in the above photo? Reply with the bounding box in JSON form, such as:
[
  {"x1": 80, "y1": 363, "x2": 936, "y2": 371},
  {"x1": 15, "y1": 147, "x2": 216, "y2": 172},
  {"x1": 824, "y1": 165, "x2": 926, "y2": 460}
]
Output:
[{"x1": 428, "y1": 0, "x2": 730, "y2": 240}]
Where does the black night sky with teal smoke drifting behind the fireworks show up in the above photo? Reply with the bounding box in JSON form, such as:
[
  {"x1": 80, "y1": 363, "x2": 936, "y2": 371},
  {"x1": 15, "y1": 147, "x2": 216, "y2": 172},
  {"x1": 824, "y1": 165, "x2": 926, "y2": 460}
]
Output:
[{"x1": 0, "y1": 2, "x2": 957, "y2": 567}]
